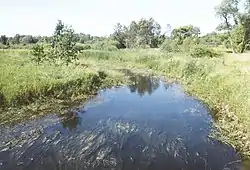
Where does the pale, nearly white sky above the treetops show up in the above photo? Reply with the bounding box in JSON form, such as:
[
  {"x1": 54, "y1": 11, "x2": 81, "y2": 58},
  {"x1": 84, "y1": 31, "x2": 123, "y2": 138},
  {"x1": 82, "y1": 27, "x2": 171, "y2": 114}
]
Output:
[{"x1": 0, "y1": 0, "x2": 221, "y2": 36}]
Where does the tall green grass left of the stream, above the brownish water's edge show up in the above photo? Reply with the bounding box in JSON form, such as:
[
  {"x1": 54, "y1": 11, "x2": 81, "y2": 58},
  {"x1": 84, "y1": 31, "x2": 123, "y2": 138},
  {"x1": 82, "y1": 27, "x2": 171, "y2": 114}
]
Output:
[{"x1": 0, "y1": 50, "x2": 123, "y2": 106}]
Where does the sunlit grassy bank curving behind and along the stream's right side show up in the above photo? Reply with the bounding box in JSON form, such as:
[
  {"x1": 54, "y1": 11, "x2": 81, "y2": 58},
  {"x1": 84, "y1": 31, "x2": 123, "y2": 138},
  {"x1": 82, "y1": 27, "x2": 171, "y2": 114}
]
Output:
[{"x1": 79, "y1": 50, "x2": 250, "y2": 157}]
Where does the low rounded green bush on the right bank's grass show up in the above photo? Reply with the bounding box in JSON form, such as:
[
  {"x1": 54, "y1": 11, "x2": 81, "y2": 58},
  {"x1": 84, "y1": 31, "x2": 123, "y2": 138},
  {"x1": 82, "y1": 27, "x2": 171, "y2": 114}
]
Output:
[{"x1": 190, "y1": 45, "x2": 220, "y2": 58}]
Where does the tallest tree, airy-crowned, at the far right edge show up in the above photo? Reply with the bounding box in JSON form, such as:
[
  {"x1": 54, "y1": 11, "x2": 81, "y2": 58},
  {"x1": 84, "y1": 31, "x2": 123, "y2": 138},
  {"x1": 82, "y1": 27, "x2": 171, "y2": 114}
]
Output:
[{"x1": 215, "y1": 0, "x2": 250, "y2": 53}]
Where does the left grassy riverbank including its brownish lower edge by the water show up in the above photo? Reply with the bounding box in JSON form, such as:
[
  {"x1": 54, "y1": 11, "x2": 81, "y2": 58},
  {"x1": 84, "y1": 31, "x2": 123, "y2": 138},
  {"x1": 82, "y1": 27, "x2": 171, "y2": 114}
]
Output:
[{"x1": 0, "y1": 50, "x2": 124, "y2": 125}]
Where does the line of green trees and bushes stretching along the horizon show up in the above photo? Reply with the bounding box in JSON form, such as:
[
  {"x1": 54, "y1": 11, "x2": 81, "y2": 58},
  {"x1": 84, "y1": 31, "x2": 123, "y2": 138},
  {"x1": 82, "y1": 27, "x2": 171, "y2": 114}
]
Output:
[{"x1": 0, "y1": 0, "x2": 250, "y2": 53}]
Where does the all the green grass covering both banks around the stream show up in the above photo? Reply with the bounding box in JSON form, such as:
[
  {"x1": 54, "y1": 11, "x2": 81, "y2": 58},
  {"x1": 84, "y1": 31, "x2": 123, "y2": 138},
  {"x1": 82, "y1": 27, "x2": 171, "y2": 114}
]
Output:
[{"x1": 0, "y1": 49, "x2": 250, "y2": 157}]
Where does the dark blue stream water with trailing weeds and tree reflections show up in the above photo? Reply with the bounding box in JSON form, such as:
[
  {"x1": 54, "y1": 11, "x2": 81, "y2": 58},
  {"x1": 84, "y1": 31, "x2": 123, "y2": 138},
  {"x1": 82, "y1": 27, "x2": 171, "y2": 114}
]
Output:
[{"x1": 0, "y1": 73, "x2": 250, "y2": 170}]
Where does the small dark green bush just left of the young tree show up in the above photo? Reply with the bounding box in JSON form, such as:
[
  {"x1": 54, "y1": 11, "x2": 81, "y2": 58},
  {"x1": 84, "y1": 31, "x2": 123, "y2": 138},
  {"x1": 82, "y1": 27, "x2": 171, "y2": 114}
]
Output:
[{"x1": 31, "y1": 44, "x2": 46, "y2": 64}]
